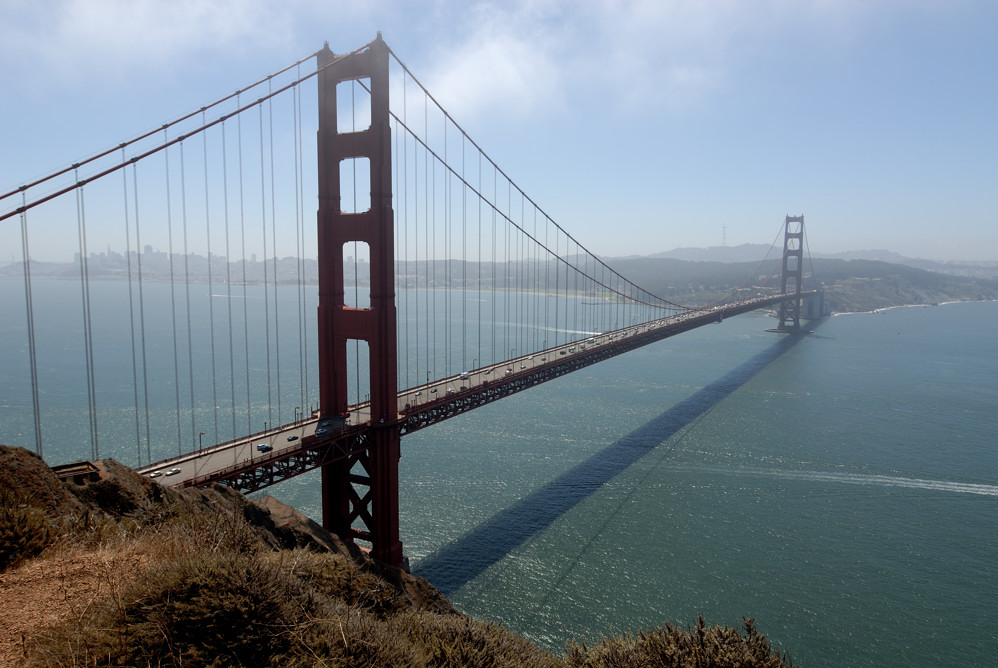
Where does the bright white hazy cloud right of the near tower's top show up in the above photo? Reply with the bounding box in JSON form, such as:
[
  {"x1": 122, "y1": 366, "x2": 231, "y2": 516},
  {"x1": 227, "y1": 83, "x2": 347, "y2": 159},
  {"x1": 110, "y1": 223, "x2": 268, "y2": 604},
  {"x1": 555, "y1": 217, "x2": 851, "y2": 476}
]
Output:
[{"x1": 410, "y1": 0, "x2": 956, "y2": 125}]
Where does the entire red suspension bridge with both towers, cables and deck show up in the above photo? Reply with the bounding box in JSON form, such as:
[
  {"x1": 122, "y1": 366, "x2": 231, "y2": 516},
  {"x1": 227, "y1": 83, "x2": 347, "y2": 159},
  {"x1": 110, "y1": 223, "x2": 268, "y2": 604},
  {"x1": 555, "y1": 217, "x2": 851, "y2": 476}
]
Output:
[{"x1": 0, "y1": 35, "x2": 822, "y2": 564}]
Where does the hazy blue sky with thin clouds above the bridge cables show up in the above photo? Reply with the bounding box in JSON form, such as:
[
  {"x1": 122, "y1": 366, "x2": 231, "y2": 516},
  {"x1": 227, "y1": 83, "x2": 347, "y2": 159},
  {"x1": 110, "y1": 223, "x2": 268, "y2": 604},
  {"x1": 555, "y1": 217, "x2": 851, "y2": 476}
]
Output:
[{"x1": 0, "y1": 0, "x2": 998, "y2": 260}]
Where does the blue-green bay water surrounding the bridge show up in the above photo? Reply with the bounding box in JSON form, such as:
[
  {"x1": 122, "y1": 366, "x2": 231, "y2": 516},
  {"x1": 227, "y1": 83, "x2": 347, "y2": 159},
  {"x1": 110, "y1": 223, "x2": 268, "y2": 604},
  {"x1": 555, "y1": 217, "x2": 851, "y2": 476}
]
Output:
[{"x1": 0, "y1": 282, "x2": 998, "y2": 666}]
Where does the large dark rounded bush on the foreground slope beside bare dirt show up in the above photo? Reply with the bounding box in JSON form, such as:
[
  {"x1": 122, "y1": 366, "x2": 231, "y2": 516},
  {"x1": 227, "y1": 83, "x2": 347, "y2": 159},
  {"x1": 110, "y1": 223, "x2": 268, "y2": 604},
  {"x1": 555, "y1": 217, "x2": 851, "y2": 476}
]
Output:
[{"x1": 40, "y1": 553, "x2": 324, "y2": 666}]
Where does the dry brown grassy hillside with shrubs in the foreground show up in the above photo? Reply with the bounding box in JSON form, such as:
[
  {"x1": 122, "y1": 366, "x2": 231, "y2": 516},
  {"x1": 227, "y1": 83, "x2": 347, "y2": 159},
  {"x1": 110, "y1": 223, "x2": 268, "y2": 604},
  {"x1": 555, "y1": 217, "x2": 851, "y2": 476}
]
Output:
[{"x1": 0, "y1": 446, "x2": 790, "y2": 668}]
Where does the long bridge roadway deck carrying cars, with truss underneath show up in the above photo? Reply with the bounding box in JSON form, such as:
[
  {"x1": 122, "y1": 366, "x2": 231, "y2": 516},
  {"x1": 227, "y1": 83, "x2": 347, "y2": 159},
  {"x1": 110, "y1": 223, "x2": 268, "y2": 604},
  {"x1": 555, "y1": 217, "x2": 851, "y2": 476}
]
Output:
[{"x1": 139, "y1": 292, "x2": 814, "y2": 492}]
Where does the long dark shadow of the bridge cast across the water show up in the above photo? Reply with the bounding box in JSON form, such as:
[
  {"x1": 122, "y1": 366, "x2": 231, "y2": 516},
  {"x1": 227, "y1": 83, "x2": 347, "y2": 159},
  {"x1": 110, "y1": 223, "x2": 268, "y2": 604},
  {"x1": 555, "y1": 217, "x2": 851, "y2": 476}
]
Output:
[{"x1": 413, "y1": 328, "x2": 804, "y2": 596}]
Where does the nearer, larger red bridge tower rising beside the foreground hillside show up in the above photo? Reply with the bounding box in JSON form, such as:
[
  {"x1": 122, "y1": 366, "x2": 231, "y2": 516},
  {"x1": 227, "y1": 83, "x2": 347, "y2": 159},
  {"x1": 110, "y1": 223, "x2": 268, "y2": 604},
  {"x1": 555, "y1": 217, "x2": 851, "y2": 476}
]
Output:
[{"x1": 316, "y1": 33, "x2": 403, "y2": 565}]
